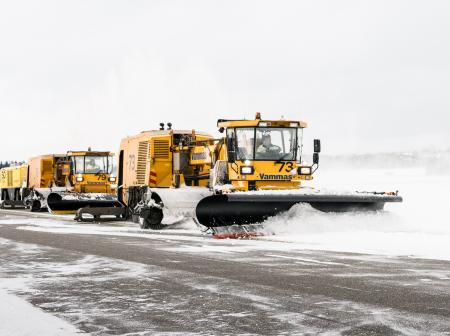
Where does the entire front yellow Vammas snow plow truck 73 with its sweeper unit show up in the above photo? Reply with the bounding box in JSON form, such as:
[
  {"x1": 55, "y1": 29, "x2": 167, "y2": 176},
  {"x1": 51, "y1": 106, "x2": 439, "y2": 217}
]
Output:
[{"x1": 77, "y1": 113, "x2": 402, "y2": 237}]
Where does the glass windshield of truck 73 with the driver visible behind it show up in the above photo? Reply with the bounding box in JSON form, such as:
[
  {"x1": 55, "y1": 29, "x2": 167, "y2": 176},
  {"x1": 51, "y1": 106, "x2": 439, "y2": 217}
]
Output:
[{"x1": 229, "y1": 127, "x2": 297, "y2": 161}]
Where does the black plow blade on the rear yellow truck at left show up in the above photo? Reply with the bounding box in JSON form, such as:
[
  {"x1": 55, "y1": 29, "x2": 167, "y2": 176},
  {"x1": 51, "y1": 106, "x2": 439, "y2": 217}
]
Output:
[{"x1": 47, "y1": 192, "x2": 123, "y2": 215}]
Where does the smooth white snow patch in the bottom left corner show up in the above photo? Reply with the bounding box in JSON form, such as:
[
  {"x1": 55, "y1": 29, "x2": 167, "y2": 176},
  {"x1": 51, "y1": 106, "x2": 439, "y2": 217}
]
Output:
[{"x1": 0, "y1": 289, "x2": 79, "y2": 336}]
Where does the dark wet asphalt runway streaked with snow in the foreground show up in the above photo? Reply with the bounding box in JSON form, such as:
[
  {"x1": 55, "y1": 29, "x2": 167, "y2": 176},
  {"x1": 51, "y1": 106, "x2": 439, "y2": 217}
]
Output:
[{"x1": 0, "y1": 211, "x2": 450, "y2": 335}]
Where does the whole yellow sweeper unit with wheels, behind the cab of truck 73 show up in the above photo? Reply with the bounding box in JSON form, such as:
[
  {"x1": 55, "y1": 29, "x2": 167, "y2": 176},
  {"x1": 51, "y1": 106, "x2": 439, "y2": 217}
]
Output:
[{"x1": 75, "y1": 124, "x2": 215, "y2": 229}]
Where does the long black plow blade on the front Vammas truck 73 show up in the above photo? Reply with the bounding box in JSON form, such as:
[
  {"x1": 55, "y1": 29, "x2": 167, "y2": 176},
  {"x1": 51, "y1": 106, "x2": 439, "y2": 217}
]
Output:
[{"x1": 195, "y1": 192, "x2": 402, "y2": 228}]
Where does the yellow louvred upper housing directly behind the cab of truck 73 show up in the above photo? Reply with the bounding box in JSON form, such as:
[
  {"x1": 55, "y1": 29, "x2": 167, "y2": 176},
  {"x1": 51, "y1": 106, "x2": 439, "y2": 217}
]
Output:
[{"x1": 118, "y1": 130, "x2": 212, "y2": 203}]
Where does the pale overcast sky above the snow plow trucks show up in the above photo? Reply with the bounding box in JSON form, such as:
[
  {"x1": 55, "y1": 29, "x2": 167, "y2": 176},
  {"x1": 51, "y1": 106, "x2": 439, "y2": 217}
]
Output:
[{"x1": 0, "y1": 0, "x2": 450, "y2": 160}]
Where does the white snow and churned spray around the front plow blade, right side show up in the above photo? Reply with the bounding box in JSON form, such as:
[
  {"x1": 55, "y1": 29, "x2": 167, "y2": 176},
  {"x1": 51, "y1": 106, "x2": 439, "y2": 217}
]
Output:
[{"x1": 267, "y1": 168, "x2": 450, "y2": 260}]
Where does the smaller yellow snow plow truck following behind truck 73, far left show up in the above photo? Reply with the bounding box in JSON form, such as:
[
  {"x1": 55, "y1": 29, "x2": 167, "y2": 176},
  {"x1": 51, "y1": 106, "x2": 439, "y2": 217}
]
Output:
[{"x1": 0, "y1": 150, "x2": 121, "y2": 214}]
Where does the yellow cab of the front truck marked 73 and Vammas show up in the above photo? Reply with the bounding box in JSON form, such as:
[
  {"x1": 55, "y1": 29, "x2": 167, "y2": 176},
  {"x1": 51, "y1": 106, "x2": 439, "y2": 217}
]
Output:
[{"x1": 217, "y1": 113, "x2": 313, "y2": 191}]
